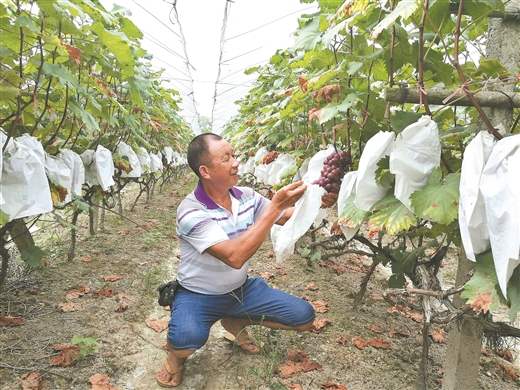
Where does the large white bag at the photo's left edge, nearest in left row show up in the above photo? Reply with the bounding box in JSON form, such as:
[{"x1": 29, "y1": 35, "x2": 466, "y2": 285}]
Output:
[{"x1": 0, "y1": 140, "x2": 53, "y2": 221}]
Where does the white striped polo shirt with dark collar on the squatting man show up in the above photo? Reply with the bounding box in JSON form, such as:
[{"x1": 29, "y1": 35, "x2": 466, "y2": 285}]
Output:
[{"x1": 176, "y1": 182, "x2": 269, "y2": 295}]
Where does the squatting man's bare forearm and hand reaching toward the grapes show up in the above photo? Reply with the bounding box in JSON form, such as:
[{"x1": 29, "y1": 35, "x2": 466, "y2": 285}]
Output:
[{"x1": 206, "y1": 181, "x2": 307, "y2": 269}]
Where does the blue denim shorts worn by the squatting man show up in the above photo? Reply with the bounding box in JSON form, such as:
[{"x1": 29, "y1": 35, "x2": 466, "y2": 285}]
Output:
[{"x1": 168, "y1": 278, "x2": 314, "y2": 350}]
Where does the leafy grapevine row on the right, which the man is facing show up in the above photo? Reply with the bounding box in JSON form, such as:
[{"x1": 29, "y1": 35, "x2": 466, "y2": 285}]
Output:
[{"x1": 224, "y1": 0, "x2": 520, "y2": 386}]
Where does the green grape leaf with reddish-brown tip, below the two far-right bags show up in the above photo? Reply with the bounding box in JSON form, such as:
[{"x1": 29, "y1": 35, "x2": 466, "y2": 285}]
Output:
[{"x1": 460, "y1": 251, "x2": 504, "y2": 312}]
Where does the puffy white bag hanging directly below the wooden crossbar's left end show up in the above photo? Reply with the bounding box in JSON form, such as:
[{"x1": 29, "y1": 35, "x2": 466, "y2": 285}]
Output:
[{"x1": 390, "y1": 115, "x2": 441, "y2": 211}]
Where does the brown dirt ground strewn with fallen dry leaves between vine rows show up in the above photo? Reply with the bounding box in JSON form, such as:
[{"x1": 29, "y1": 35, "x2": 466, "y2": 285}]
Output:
[{"x1": 0, "y1": 176, "x2": 518, "y2": 390}]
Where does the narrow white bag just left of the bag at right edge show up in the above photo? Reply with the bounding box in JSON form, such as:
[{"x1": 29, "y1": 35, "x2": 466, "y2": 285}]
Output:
[{"x1": 459, "y1": 130, "x2": 496, "y2": 261}]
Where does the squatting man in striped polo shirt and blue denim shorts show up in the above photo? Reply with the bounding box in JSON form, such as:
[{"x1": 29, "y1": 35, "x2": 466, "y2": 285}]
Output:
[{"x1": 157, "y1": 133, "x2": 332, "y2": 387}]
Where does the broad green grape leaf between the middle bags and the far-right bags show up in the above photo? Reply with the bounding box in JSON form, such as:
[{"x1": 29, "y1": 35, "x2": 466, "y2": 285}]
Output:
[{"x1": 410, "y1": 168, "x2": 460, "y2": 225}]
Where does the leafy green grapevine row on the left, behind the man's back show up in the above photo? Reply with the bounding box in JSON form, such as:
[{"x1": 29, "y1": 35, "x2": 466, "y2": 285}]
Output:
[{"x1": 0, "y1": 0, "x2": 193, "y2": 290}]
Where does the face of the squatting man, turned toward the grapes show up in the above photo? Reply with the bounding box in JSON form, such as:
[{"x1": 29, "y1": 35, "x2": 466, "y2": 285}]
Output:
[{"x1": 207, "y1": 139, "x2": 240, "y2": 188}]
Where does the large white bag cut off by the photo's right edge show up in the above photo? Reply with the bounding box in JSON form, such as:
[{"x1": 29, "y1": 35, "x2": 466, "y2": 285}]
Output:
[{"x1": 480, "y1": 134, "x2": 520, "y2": 297}]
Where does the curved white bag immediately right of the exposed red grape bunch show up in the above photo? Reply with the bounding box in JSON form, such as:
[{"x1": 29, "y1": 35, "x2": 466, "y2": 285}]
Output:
[{"x1": 354, "y1": 131, "x2": 395, "y2": 211}]
